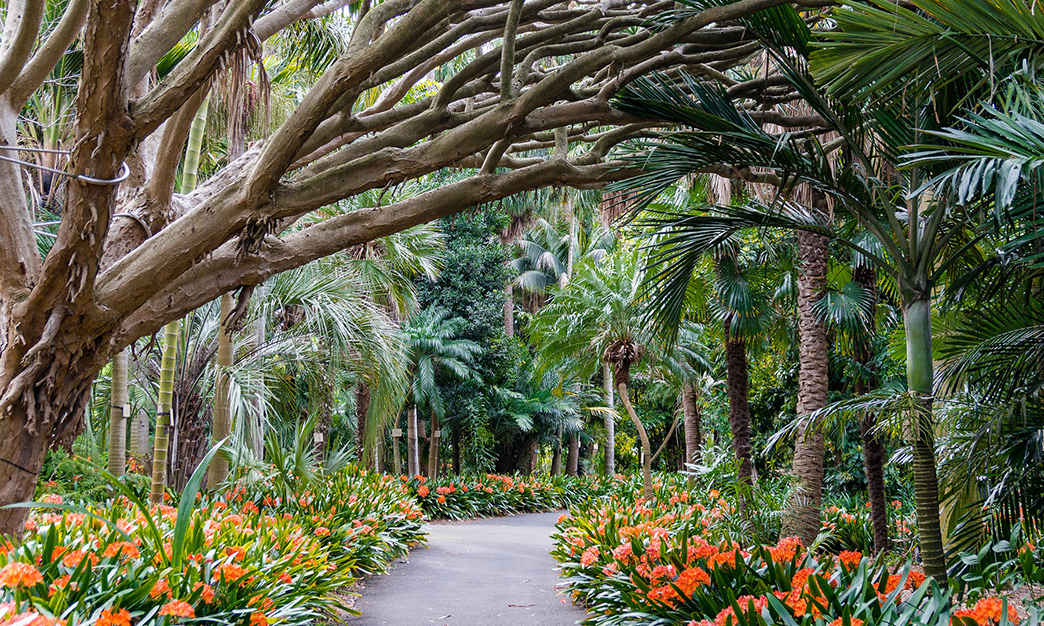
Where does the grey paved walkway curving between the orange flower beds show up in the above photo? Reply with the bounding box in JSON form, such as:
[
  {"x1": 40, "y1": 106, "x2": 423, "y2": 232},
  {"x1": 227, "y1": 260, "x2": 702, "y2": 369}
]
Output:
[{"x1": 348, "y1": 512, "x2": 585, "y2": 626}]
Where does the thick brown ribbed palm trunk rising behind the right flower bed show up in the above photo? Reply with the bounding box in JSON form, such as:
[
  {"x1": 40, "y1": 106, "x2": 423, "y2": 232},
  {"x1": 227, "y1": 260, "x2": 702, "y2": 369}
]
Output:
[{"x1": 781, "y1": 232, "x2": 830, "y2": 546}]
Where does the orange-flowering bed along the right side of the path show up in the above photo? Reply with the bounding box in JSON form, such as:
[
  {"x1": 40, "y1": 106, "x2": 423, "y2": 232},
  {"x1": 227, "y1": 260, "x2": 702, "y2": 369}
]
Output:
[{"x1": 552, "y1": 483, "x2": 1017, "y2": 626}]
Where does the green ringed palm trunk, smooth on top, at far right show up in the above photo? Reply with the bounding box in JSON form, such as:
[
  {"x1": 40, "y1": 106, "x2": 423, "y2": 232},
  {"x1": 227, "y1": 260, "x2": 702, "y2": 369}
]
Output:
[{"x1": 903, "y1": 293, "x2": 947, "y2": 587}]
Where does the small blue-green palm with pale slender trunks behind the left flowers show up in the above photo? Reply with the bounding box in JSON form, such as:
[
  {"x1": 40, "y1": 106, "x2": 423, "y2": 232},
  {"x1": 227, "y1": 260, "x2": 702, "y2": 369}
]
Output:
[{"x1": 396, "y1": 308, "x2": 481, "y2": 478}]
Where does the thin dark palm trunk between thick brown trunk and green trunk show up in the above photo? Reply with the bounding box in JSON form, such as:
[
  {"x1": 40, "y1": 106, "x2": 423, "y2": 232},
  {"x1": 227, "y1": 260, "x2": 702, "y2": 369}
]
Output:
[{"x1": 852, "y1": 265, "x2": 892, "y2": 554}]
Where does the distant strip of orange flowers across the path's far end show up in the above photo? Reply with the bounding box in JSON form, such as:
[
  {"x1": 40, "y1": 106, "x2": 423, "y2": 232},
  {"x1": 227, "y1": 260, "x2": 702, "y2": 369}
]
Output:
[{"x1": 400, "y1": 474, "x2": 615, "y2": 520}]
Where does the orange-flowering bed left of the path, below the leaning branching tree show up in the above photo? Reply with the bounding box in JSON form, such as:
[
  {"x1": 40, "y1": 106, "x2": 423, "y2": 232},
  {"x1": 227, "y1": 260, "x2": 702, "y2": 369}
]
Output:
[{"x1": 0, "y1": 472, "x2": 422, "y2": 626}]
